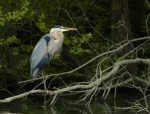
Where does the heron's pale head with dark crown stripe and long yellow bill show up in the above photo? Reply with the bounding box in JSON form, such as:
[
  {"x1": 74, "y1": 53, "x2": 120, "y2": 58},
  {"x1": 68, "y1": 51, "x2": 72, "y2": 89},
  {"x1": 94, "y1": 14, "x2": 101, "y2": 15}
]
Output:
[{"x1": 50, "y1": 25, "x2": 77, "y2": 32}]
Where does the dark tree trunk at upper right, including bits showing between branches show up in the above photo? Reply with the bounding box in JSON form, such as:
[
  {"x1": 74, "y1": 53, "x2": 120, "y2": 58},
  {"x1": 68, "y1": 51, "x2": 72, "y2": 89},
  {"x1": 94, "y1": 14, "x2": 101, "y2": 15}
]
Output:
[{"x1": 111, "y1": 0, "x2": 137, "y2": 74}]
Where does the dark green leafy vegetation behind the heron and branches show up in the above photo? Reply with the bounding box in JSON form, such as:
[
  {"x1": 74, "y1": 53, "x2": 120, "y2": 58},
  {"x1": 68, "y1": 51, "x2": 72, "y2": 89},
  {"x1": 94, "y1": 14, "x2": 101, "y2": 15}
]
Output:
[{"x1": 0, "y1": 0, "x2": 150, "y2": 91}]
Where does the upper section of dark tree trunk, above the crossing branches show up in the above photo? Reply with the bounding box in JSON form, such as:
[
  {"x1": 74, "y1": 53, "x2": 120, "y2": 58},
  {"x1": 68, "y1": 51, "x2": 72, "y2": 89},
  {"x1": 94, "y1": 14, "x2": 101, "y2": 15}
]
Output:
[{"x1": 111, "y1": 0, "x2": 131, "y2": 43}]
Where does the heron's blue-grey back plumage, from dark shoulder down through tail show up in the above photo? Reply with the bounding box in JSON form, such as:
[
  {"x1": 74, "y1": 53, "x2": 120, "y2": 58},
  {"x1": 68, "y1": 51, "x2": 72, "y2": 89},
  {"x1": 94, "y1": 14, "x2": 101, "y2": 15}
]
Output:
[{"x1": 30, "y1": 34, "x2": 51, "y2": 78}]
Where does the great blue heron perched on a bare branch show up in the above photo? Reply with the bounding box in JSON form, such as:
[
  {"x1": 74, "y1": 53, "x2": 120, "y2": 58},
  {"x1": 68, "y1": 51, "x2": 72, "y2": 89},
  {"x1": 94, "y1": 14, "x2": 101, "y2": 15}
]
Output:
[{"x1": 30, "y1": 25, "x2": 77, "y2": 79}]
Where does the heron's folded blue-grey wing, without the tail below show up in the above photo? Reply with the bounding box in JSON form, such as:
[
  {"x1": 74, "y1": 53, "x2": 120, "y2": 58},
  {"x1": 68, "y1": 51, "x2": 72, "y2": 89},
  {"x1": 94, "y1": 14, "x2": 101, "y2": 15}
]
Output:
[{"x1": 30, "y1": 34, "x2": 51, "y2": 74}]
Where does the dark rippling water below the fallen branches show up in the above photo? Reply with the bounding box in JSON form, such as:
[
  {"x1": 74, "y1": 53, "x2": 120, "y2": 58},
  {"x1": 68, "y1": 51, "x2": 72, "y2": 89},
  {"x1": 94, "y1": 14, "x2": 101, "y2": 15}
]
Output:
[{"x1": 0, "y1": 89, "x2": 149, "y2": 114}]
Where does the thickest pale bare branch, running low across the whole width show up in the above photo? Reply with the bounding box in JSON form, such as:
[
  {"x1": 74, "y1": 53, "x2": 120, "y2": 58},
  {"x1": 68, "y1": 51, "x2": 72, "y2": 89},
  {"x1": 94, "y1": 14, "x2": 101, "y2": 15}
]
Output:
[{"x1": 0, "y1": 58, "x2": 150, "y2": 103}]
